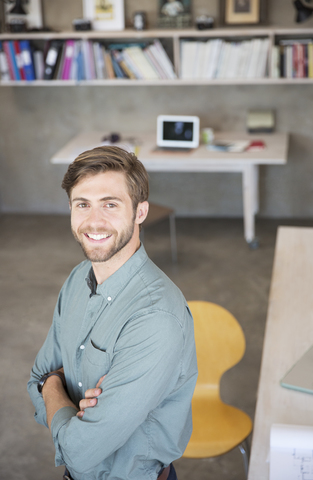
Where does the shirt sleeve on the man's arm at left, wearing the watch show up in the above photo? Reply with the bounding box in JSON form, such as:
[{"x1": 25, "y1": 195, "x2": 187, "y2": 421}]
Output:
[{"x1": 27, "y1": 288, "x2": 62, "y2": 428}]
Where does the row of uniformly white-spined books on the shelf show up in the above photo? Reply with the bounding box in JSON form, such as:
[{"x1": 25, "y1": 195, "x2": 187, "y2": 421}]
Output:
[{"x1": 180, "y1": 38, "x2": 270, "y2": 79}]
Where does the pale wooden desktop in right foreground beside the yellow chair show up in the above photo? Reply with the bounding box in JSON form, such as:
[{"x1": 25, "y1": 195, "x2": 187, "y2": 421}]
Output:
[{"x1": 248, "y1": 227, "x2": 313, "y2": 480}]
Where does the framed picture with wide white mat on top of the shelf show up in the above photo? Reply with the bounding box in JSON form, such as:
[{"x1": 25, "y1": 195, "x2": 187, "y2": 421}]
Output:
[{"x1": 83, "y1": 0, "x2": 125, "y2": 30}]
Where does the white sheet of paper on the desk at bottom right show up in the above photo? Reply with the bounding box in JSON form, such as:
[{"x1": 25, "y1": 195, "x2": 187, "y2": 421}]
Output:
[{"x1": 270, "y1": 424, "x2": 313, "y2": 480}]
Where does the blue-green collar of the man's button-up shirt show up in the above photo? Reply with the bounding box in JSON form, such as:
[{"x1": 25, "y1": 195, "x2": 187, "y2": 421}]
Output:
[{"x1": 86, "y1": 244, "x2": 148, "y2": 303}]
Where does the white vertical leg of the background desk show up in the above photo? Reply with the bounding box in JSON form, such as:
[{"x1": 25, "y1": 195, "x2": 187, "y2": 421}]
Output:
[{"x1": 242, "y1": 165, "x2": 259, "y2": 248}]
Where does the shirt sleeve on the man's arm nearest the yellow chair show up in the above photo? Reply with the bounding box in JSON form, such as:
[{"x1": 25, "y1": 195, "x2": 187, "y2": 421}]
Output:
[{"x1": 51, "y1": 311, "x2": 185, "y2": 473}]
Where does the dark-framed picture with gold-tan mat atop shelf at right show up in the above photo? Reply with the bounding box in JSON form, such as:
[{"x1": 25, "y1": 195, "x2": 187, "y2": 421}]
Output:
[{"x1": 221, "y1": 0, "x2": 266, "y2": 25}]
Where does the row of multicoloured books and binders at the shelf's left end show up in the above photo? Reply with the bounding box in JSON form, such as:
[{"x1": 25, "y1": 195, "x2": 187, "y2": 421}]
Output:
[{"x1": 0, "y1": 39, "x2": 176, "y2": 81}]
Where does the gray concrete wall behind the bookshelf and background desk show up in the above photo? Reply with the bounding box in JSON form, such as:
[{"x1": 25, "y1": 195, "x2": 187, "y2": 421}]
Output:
[{"x1": 0, "y1": 0, "x2": 313, "y2": 218}]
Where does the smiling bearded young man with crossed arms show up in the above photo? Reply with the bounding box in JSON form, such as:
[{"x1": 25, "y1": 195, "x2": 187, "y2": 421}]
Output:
[{"x1": 28, "y1": 147, "x2": 197, "y2": 480}]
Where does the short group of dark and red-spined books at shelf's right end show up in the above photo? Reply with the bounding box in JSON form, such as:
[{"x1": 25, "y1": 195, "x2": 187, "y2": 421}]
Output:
[{"x1": 271, "y1": 39, "x2": 313, "y2": 78}]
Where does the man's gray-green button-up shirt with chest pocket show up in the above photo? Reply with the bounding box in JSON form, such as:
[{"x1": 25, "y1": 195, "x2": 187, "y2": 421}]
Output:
[{"x1": 28, "y1": 246, "x2": 197, "y2": 480}]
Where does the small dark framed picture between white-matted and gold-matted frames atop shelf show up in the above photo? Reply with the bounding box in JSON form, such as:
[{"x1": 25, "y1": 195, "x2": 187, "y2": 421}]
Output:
[{"x1": 158, "y1": 0, "x2": 191, "y2": 28}]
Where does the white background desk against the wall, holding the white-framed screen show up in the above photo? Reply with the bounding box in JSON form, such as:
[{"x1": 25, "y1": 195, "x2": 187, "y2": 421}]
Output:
[{"x1": 51, "y1": 132, "x2": 288, "y2": 245}]
